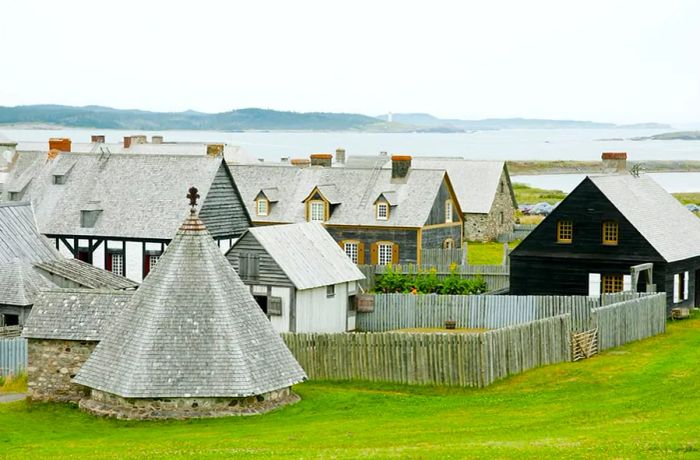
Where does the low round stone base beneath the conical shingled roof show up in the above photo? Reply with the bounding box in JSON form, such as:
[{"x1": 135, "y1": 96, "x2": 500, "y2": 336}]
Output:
[{"x1": 80, "y1": 388, "x2": 300, "y2": 420}]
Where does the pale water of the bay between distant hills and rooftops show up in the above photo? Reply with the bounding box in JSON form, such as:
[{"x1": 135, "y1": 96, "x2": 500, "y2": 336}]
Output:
[{"x1": 0, "y1": 128, "x2": 700, "y2": 161}]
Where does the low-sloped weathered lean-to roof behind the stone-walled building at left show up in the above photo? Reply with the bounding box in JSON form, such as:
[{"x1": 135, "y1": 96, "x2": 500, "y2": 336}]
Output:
[{"x1": 34, "y1": 259, "x2": 139, "y2": 290}]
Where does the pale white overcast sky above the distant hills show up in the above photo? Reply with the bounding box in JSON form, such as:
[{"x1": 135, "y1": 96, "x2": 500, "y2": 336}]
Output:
[{"x1": 0, "y1": 0, "x2": 700, "y2": 123}]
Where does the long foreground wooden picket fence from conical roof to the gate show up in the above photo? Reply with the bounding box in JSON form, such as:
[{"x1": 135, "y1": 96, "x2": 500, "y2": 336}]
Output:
[{"x1": 282, "y1": 315, "x2": 571, "y2": 387}]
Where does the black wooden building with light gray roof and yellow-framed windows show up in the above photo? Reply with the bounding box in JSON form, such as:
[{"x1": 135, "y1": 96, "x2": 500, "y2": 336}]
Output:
[{"x1": 510, "y1": 173, "x2": 700, "y2": 310}]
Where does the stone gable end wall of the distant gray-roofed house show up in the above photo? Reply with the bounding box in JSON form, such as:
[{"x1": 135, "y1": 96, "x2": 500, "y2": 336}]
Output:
[{"x1": 464, "y1": 171, "x2": 515, "y2": 241}]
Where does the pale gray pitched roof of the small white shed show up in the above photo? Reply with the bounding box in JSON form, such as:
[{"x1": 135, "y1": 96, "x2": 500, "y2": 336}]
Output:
[{"x1": 233, "y1": 222, "x2": 365, "y2": 289}]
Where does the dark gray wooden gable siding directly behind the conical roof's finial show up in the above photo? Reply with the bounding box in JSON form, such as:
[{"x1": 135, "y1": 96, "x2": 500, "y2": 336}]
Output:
[{"x1": 199, "y1": 163, "x2": 252, "y2": 238}]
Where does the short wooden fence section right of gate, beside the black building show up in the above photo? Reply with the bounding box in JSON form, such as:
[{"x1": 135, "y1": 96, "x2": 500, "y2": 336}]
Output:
[{"x1": 592, "y1": 293, "x2": 666, "y2": 351}]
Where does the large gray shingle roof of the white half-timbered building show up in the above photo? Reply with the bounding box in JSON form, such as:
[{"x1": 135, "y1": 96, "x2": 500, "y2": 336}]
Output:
[{"x1": 2, "y1": 153, "x2": 234, "y2": 240}]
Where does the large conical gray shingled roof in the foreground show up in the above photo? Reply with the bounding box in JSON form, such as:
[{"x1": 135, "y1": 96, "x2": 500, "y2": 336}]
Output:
[{"x1": 74, "y1": 207, "x2": 306, "y2": 398}]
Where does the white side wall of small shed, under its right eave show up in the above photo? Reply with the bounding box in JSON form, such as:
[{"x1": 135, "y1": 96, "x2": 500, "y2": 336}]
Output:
[{"x1": 296, "y1": 283, "x2": 348, "y2": 332}]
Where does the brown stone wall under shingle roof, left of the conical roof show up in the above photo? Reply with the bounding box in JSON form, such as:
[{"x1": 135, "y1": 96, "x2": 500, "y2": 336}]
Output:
[{"x1": 27, "y1": 339, "x2": 97, "y2": 403}]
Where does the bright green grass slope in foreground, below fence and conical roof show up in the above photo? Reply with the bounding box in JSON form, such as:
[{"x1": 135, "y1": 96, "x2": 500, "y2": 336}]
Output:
[{"x1": 0, "y1": 318, "x2": 700, "y2": 459}]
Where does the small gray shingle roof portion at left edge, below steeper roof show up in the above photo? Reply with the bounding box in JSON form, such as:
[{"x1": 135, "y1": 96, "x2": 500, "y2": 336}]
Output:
[{"x1": 0, "y1": 259, "x2": 56, "y2": 307}]
